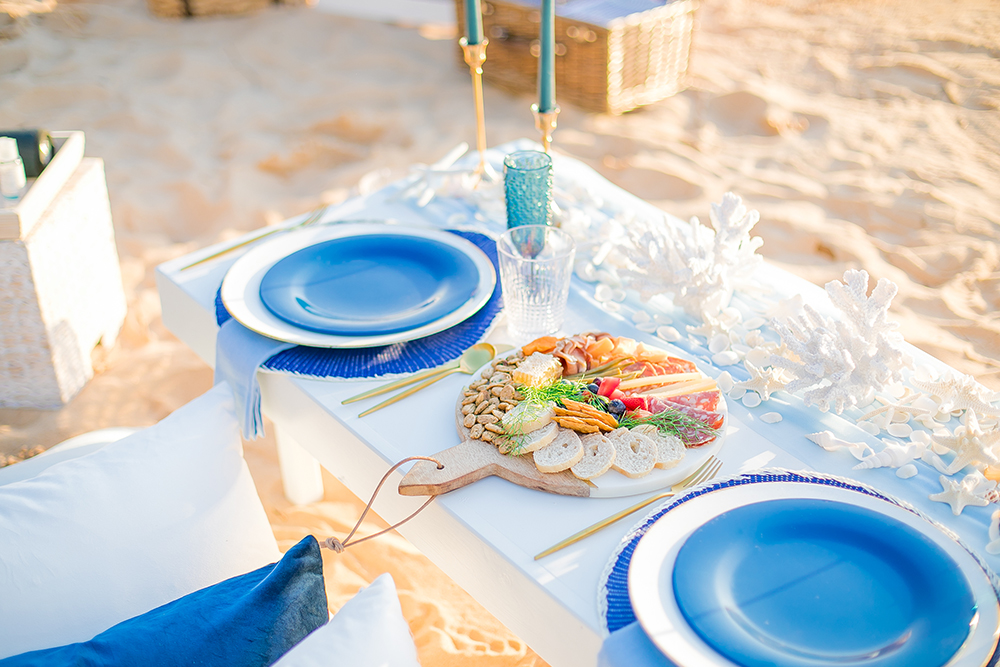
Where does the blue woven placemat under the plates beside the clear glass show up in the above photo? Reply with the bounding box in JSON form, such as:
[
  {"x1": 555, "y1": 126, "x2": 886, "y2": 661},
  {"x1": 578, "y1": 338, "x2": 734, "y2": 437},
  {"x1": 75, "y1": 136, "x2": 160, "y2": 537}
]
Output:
[{"x1": 215, "y1": 230, "x2": 503, "y2": 378}]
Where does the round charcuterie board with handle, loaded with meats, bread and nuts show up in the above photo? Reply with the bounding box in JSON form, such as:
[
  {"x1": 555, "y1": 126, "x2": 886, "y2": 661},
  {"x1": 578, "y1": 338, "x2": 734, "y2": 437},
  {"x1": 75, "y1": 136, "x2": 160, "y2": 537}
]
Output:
[{"x1": 399, "y1": 333, "x2": 727, "y2": 498}]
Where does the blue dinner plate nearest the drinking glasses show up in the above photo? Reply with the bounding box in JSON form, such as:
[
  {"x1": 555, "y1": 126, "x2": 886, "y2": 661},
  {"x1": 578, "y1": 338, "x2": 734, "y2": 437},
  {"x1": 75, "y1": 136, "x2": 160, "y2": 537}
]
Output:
[{"x1": 260, "y1": 234, "x2": 479, "y2": 336}]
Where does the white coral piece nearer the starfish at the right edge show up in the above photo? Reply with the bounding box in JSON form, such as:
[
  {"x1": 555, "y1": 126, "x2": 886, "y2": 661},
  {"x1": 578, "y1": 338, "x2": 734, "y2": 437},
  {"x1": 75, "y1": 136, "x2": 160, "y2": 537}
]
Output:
[{"x1": 771, "y1": 270, "x2": 912, "y2": 414}]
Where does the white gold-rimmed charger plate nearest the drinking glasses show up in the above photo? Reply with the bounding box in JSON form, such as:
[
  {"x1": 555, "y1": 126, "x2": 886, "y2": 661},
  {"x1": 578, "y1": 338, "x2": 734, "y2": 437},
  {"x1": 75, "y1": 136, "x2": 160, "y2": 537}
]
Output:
[{"x1": 222, "y1": 223, "x2": 497, "y2": 348}]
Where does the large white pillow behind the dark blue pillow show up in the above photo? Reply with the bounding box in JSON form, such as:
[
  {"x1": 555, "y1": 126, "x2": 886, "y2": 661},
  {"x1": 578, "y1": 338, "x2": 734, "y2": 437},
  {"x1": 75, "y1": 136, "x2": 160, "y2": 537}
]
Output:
[{"x1": 0, "y1": 384, "x2": 281, "y2": 658}]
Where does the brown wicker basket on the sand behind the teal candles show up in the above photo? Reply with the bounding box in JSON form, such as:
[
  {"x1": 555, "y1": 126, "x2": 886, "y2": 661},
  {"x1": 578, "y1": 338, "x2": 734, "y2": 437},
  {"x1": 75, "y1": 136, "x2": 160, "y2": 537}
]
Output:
[{"x1": 455, "y1": 0, "x2": 696, "y2": 114}]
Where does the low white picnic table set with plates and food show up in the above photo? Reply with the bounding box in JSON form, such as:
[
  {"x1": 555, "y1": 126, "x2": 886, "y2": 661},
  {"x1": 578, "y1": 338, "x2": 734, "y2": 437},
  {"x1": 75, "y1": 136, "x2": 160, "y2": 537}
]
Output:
[{"x1": 157, "y1": 144, "x2": 994, "y2": 667}]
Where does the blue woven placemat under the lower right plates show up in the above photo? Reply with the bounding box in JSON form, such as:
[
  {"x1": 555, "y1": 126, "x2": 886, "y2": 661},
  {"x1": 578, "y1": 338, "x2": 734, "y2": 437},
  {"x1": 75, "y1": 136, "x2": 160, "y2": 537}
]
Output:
[{"x1": 598, "y1": 470, "x2": 1000, "y2": 640}]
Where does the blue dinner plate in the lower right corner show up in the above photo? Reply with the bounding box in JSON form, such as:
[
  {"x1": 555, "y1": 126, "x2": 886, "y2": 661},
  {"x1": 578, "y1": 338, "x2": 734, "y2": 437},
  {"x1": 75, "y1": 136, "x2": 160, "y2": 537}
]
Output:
[{"x1": 673, "y1": 499, "x2": 977, "y2": 667}]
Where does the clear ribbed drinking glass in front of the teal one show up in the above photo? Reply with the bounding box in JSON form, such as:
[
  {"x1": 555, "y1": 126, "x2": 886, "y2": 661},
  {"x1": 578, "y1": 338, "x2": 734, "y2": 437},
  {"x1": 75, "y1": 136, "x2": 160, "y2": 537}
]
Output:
[{"x1": 497, "y1": 225, "x2": 576, "y2": 342}]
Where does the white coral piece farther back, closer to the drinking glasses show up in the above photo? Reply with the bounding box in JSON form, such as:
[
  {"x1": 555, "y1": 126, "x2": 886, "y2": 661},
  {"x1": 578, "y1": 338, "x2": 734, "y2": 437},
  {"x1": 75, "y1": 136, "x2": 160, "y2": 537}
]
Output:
[{"x1": 621, "y1": 192, "x2": 763, "y2": 320}]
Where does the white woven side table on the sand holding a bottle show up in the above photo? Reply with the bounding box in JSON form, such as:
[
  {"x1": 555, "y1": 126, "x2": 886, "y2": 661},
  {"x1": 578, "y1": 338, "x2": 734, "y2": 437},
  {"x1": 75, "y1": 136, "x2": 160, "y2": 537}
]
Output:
[{"x1": 0, "y1": 149, "x2": 126, "y2": 408}]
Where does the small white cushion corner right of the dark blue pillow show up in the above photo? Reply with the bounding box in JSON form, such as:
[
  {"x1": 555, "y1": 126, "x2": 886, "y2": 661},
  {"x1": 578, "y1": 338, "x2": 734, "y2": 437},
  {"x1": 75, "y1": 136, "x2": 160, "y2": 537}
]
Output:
[{"x1": 273, "y1": 574, "x2": 420, "y2": 667}]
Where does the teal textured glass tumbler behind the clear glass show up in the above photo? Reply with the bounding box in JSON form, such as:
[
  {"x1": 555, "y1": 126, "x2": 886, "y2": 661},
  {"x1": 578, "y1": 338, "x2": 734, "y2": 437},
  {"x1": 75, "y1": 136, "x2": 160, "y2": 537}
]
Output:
[{"x1": 503, "y1": 151, "x2": 552, "y2": 228}]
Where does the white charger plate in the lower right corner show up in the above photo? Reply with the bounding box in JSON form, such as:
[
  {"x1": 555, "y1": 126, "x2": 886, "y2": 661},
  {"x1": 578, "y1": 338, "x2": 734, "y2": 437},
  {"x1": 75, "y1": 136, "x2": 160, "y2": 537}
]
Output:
[{"x1": 628, "y1": 482, "x2": 1000, "y2": 667}]
